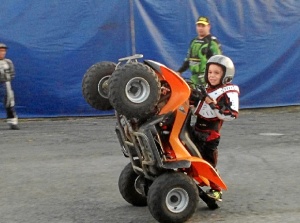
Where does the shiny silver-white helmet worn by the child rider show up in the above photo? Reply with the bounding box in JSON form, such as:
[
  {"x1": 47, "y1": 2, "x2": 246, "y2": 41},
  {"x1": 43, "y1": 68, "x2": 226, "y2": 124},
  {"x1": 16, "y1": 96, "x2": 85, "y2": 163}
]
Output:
[{"x1": 204, "y1": 55, "x2": 235, "y2": 84}]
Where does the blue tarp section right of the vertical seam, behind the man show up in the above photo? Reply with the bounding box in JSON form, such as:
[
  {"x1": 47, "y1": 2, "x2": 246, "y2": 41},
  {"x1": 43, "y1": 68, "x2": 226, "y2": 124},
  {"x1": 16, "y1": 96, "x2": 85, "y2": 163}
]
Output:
[{"x1": 135, "y1": 0, "x2": 300, "y2": 108}]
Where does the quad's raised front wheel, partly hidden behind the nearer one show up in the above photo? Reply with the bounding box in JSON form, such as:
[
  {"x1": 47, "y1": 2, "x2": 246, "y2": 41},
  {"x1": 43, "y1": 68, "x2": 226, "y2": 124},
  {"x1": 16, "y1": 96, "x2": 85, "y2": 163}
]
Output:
[{"x1": 82, "y1": 61, "x2": 116, "y2": 110}]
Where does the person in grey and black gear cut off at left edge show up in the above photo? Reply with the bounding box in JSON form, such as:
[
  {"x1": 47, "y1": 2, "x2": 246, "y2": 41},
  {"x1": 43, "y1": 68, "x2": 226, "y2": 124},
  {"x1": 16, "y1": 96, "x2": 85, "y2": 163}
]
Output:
[{"x1": 0, "y1": 43, "x2": 19, "y2": 130}]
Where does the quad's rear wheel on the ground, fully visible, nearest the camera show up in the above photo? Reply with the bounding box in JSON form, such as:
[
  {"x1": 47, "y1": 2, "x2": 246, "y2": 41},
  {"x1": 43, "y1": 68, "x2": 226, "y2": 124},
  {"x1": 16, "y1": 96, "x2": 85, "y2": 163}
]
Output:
[{"x1": 148, "y1": 172, "x2": 199, "y2": 223}]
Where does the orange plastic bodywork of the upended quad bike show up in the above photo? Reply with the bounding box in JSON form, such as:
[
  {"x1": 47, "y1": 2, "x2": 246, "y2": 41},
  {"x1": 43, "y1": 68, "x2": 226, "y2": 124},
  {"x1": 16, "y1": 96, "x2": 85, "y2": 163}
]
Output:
[{"x1": 155, "y1": 62, "x2": 227, "y2": 189}]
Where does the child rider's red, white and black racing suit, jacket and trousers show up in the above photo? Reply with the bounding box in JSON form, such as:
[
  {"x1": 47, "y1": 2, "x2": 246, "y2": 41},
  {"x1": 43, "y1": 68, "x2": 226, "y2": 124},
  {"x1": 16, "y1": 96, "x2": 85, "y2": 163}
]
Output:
[{"x1": 193, "y1": 84, "x2": 239, "y2": 190}]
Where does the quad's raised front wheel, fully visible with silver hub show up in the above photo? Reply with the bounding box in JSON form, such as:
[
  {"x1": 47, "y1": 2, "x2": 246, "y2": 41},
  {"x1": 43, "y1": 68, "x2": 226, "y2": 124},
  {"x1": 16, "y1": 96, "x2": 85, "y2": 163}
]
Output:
[{"x1": 109, "y1": 63, "x2": 161, "y2": 118}]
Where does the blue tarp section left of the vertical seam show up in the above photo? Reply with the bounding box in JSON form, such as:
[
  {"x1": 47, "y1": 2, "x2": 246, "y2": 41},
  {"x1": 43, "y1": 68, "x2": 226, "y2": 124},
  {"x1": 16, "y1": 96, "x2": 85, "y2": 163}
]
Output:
[{"x1": 0, "y1": 0, "x2": 131, "y2": 117}]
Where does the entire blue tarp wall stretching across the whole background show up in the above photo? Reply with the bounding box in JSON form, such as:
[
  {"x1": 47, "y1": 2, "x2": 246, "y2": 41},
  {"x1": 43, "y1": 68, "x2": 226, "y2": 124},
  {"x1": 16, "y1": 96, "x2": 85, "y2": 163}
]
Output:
[{"x1": 0, "y1": 0, "x2": 300, "y2": 117}]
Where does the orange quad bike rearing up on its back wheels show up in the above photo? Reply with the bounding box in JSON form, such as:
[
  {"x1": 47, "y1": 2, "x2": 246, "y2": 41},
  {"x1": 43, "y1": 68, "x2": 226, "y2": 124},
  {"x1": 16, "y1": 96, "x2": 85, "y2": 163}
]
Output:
[{"x1": 82, "y1": 54, "x2": 227, "y2": 222}]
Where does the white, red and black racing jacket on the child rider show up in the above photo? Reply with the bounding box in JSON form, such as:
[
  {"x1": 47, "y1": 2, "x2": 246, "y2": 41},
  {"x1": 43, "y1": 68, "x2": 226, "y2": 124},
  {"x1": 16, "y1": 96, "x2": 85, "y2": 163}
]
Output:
[{"x1": 194, "y1": 84, "x2": 239, "y2": 141}]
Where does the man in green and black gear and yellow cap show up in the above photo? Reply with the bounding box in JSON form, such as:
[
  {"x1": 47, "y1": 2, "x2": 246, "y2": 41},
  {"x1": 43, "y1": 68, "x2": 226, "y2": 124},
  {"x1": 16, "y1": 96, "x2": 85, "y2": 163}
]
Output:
[{"x1": 177, "y1": 16, "x2": 222, "y2": 85}]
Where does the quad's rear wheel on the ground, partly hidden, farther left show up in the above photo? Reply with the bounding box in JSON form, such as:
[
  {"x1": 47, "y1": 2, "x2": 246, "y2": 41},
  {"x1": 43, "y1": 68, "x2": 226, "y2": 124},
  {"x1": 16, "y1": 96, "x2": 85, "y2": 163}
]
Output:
[{"x1": 118, "y1": 163, "x2": 147, "y2": 206}]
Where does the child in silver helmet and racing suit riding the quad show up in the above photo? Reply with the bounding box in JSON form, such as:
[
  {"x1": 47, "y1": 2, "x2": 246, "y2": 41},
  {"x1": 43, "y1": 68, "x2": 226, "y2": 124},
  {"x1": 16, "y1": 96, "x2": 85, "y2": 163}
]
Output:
[{"x1": 190, "y1": 55, "x2": 239, "y2": 201}]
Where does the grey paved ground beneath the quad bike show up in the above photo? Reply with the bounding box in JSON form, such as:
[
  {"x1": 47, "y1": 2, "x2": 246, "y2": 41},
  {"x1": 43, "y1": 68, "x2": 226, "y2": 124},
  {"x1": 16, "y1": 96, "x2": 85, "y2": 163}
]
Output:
[{"x1": 0, "y1": 107, "x2": 300, "y2": 223}]
